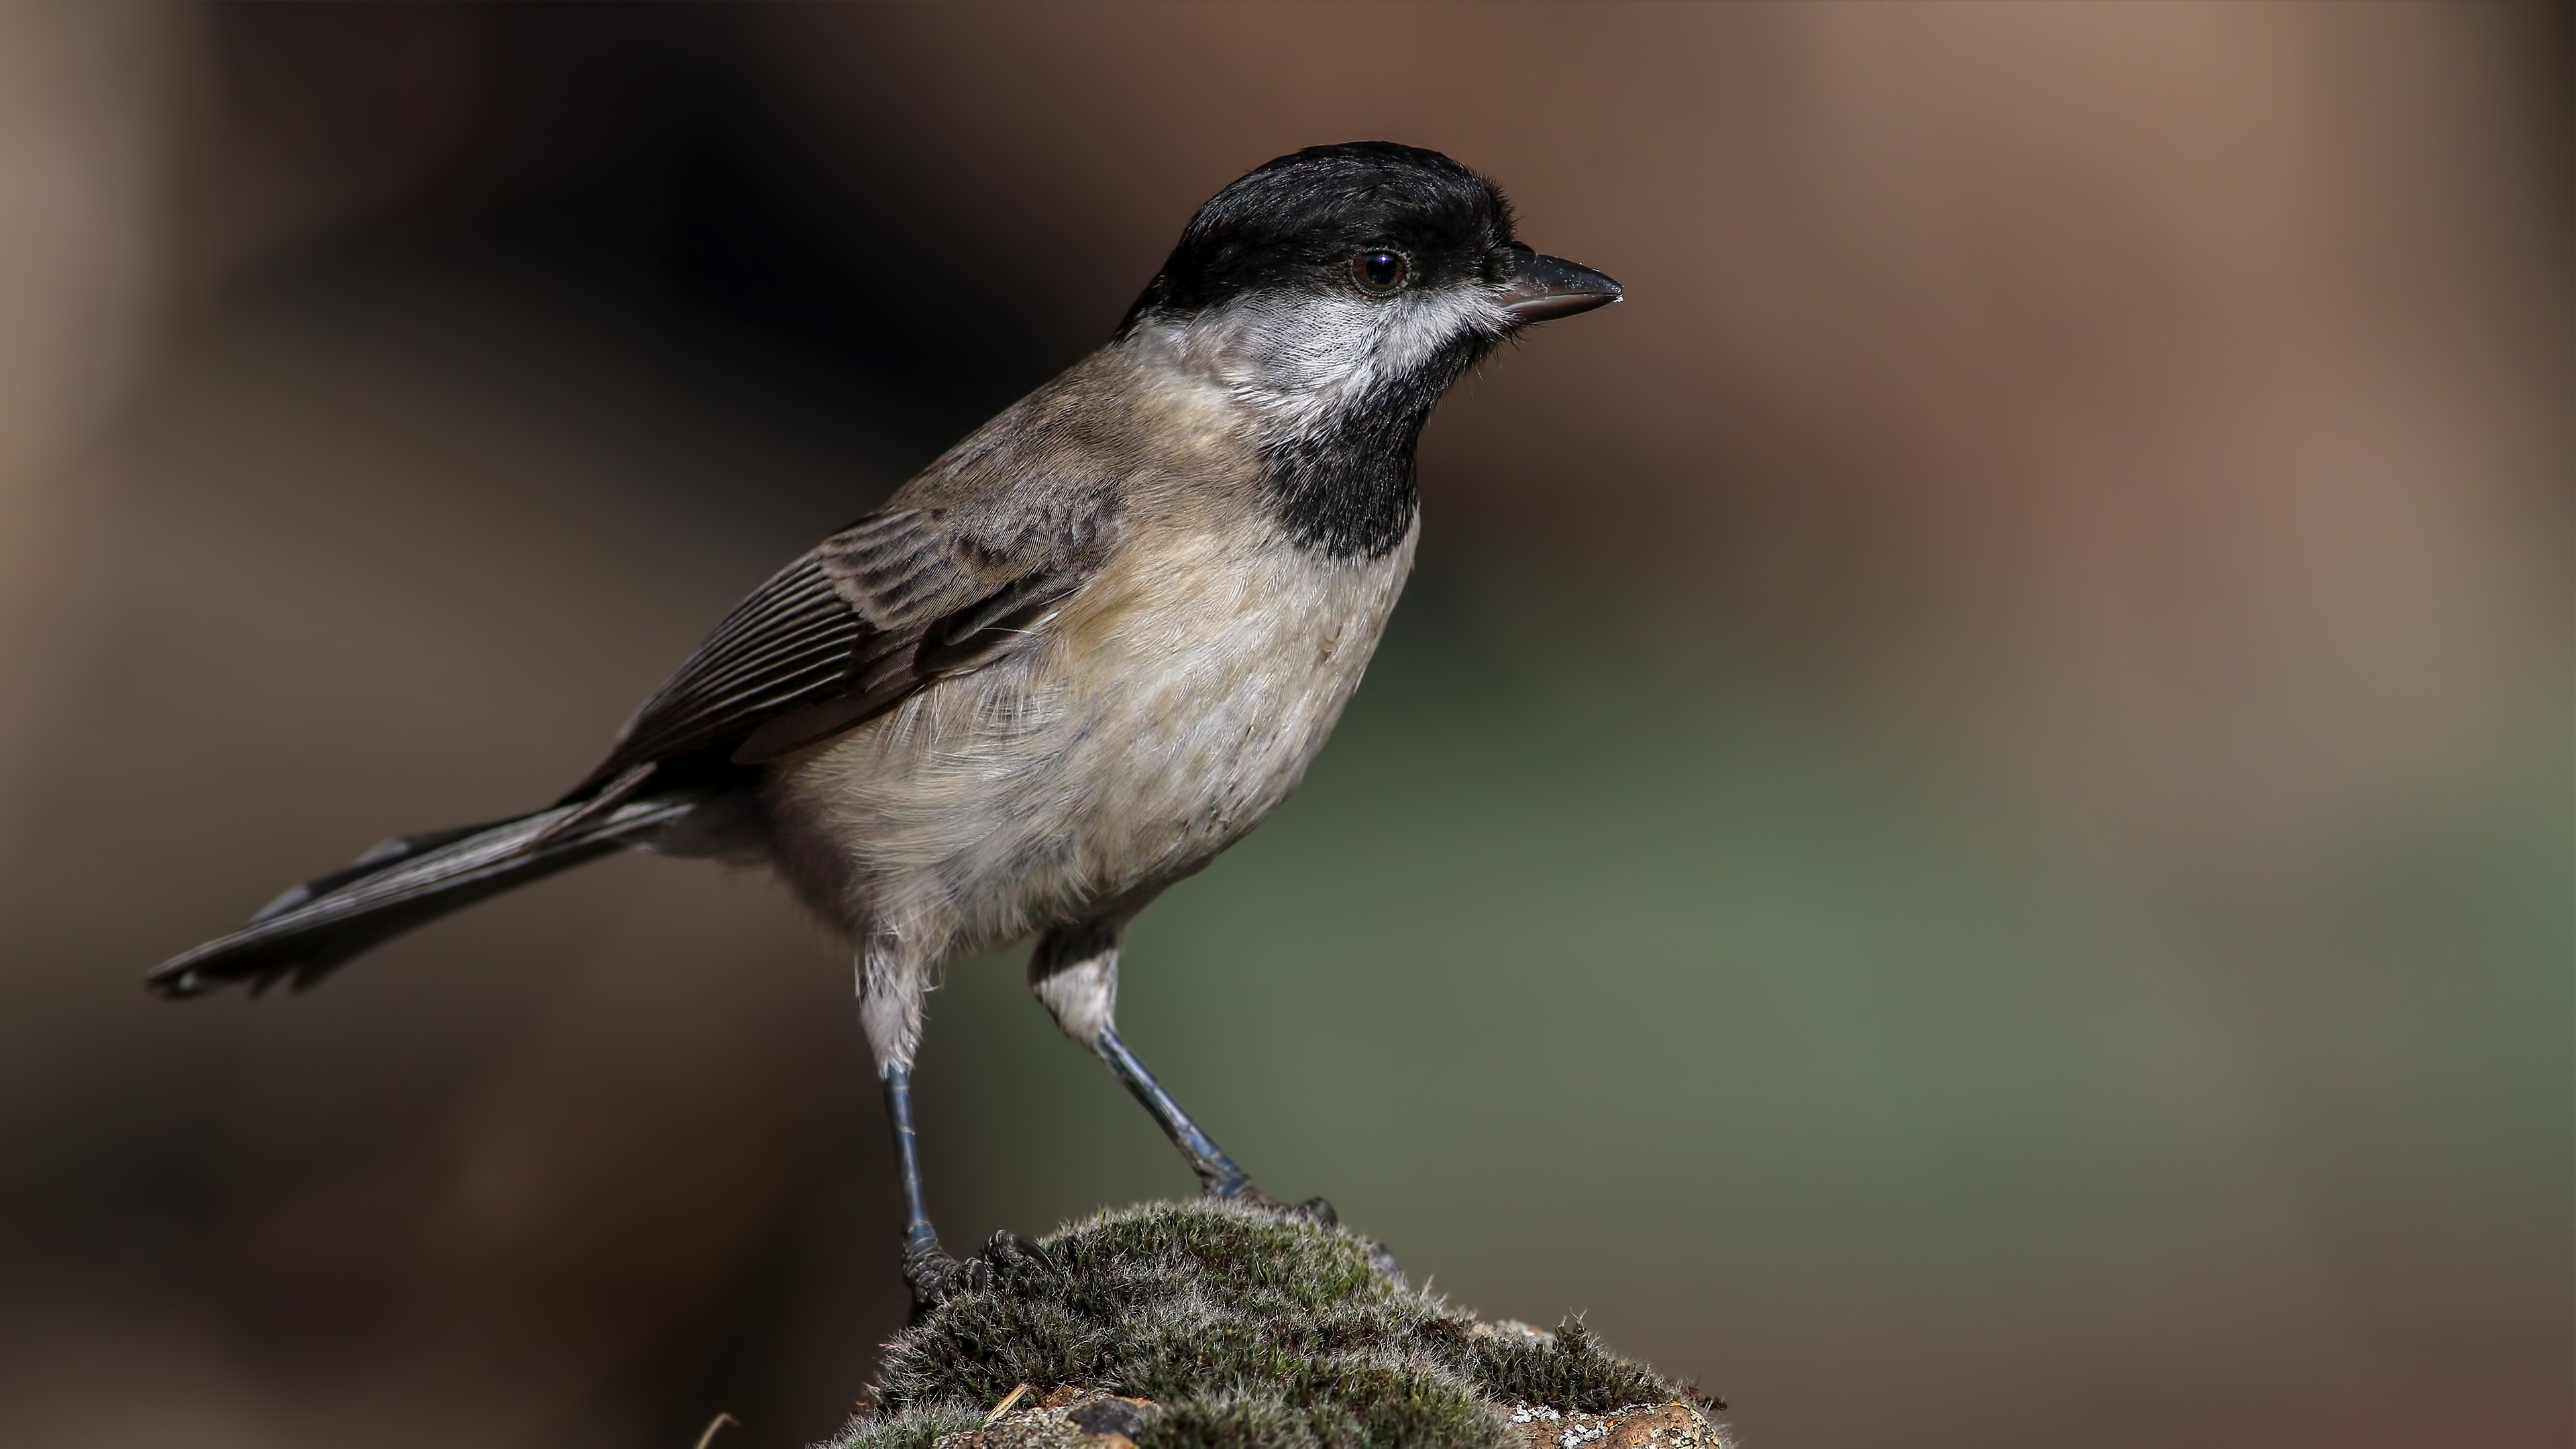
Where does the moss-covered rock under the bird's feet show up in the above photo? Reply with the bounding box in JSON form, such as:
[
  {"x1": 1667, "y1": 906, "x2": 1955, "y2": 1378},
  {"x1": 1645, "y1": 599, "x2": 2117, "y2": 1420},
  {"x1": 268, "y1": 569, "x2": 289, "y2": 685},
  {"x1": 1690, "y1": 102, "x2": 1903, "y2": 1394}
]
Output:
[{"x1": 829, "y1": 1201, "x2": 1718, "y2": 1449}]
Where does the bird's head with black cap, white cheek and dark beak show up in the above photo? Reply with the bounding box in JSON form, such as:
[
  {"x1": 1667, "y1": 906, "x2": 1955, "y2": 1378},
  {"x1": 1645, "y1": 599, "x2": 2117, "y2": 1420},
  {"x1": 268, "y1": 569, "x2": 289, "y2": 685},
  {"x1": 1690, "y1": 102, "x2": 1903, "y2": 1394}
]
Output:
[{"x1": 1118, "y1": 142, "x2": 1620, "y2": 441}]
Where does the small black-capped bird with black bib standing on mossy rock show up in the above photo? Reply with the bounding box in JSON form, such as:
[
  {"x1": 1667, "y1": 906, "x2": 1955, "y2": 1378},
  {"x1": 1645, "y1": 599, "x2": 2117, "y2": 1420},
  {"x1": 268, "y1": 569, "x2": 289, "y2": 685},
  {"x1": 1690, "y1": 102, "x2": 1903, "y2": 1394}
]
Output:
[{"x1": 150, "y1": 142, "x2": 1620, "y2": 1309}]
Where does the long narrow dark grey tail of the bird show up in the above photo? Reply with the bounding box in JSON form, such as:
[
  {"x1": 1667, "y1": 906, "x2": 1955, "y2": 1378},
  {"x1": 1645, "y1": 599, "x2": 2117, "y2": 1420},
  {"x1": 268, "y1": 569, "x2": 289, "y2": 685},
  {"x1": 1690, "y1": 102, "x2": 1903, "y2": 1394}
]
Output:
[{"x1": 144, "y1": 797, "x2": 693, "y2": 996}]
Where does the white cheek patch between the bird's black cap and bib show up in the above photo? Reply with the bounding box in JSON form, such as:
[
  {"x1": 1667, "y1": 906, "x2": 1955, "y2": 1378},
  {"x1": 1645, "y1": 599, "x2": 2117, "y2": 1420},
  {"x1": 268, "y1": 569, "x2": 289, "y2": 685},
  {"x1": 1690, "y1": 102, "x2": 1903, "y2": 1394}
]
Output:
[{"x1": 1183, "y1": 286, "x2": 1509, "y2": 436}]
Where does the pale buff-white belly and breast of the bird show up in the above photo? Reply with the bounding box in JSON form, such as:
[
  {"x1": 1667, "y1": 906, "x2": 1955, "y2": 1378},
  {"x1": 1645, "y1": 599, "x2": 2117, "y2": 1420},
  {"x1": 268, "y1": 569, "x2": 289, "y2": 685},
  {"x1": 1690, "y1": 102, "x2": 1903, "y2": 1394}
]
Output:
[{"x1": 770, "y1": 515, "x2": 1414, "y2": 967}]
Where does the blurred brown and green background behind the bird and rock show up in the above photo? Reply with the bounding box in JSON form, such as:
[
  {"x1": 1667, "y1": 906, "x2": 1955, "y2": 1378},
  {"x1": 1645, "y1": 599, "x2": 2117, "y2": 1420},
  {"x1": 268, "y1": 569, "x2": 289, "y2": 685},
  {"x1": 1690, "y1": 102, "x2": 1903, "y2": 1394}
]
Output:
[{"x1": 0, "y1": 3, "x2": 2576, "y2": 1449}]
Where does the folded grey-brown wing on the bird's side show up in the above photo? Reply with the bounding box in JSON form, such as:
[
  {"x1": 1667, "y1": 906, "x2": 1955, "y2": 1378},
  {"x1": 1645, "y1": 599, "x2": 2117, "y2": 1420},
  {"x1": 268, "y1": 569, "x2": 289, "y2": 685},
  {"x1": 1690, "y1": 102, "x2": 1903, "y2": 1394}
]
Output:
[{"x1": 567, "y1": 508, "x2": 1087, "y2": 804}]
